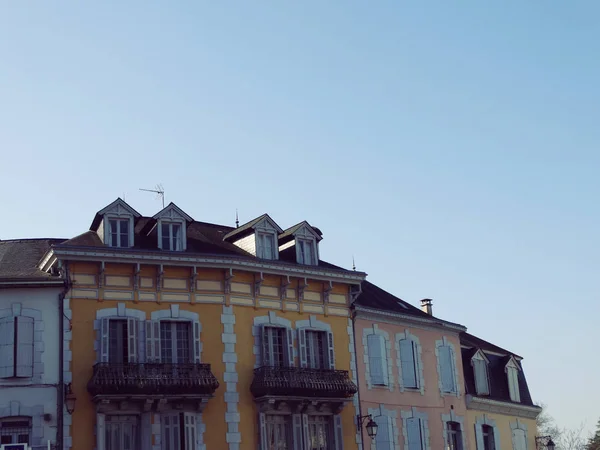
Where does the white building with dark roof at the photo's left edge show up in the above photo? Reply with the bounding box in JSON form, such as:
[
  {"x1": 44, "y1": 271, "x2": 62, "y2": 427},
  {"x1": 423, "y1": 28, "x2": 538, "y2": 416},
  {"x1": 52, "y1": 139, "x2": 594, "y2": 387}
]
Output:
[{"x1": 0, "y1": 239, "x2": 65, "y2": 449}]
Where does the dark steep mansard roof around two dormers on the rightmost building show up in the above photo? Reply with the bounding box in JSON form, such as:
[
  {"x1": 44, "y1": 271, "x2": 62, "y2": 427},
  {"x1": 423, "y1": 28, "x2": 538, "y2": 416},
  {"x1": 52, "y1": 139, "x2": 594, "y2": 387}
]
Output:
[{"x1": 460, "y1": 333, "x2": 534, "y2": 406}]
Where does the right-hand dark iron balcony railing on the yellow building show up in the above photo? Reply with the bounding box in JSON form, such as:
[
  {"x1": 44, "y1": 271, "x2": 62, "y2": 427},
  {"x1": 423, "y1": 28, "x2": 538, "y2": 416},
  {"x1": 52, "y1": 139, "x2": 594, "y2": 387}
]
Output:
[{"x1": 250, "y1": 366, "x2": 357, "y2": 398}]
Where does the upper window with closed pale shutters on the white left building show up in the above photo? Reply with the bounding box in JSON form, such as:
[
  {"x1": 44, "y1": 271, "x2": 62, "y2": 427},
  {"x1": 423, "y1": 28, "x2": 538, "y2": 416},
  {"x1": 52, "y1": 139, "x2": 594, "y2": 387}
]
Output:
[{"x1": 0, "y1": 316, "x2": 34, "y2": 378}]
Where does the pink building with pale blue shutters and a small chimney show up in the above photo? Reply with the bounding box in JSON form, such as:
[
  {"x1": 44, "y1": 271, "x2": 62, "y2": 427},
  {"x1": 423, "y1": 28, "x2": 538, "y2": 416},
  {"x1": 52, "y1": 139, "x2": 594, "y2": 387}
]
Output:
[{"x1": 354, "y1": 281, "x2": 469, "y2": 450}]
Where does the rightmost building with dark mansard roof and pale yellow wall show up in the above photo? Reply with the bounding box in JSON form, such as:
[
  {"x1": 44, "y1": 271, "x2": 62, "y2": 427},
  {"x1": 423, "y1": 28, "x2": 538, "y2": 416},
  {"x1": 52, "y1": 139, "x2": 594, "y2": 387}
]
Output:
[{"x1": 460, "y1": 333, "x2": 541, "y2": 450}]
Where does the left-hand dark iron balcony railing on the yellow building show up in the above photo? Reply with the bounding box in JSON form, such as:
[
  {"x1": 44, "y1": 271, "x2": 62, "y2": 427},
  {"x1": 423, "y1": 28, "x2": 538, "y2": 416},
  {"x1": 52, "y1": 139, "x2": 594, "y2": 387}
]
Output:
[{"x1": 88, "y1": 362, "x2": 219, "y2": 395}]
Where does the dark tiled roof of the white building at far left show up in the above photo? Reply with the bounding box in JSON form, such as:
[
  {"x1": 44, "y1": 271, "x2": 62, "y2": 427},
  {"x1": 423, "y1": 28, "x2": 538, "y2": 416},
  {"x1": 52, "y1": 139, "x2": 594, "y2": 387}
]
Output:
[{"x1": 0, "y1": 238, "x2": 64, "y2": 280}]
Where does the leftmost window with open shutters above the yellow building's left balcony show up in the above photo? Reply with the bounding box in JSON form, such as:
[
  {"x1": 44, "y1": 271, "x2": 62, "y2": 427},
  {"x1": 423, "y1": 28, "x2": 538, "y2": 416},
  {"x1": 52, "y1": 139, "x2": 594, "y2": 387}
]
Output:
[{"x1": 100, "y1": 317, "x2": 139, "y2": 364}]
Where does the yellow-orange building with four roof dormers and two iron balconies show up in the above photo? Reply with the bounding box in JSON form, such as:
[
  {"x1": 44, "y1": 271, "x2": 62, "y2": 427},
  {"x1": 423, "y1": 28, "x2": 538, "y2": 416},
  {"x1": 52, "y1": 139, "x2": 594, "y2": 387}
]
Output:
[{"x1": 39, "y1": 199, "x2": 366, "y2": 450}]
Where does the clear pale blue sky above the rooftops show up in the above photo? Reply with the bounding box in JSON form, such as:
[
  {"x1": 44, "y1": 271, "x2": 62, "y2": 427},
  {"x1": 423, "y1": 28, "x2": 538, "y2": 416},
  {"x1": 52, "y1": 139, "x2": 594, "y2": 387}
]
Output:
[{"x1": 0, "y1": 0, "x2": 600, "y2": 436}]
